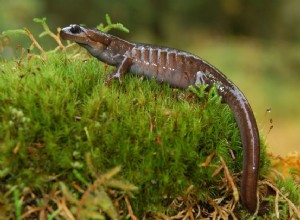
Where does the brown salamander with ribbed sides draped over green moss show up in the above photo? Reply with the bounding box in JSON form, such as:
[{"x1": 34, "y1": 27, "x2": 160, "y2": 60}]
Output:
[{"x1": 60, "y1": 24, "x2": 260, "y2": 213}]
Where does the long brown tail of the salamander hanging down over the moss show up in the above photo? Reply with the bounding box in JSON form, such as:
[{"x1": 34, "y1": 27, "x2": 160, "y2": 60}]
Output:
[{"x1": 222, "y1": 86, "x2": 260, "y2": 213}]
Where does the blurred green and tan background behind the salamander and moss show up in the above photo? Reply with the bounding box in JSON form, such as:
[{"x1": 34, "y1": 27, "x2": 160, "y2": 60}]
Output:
[{"x1": 0, "y1": 0, "x2": 300, "y2": 155}]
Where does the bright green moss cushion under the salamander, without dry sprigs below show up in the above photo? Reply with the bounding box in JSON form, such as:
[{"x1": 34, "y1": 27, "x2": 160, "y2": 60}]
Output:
[{"x1": 0, "y1": 53, "x2": 298, "y2": 219}]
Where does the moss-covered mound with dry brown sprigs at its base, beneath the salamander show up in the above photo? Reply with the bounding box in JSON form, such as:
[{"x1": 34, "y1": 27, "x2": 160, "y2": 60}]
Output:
[{"x1": 0, "y1": 27, "x2": 299, "y2": 219}]
